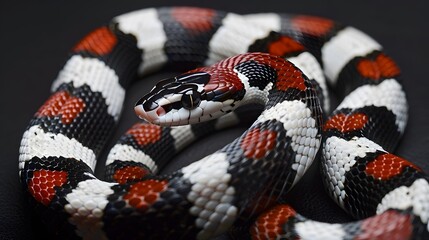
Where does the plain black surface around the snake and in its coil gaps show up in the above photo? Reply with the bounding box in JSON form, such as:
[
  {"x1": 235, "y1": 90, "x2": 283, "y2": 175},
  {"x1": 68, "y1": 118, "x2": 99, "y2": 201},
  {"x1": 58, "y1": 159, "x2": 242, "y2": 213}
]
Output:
[{"x1": 0, "y1": 0, "x2": 429, "y2": 239}]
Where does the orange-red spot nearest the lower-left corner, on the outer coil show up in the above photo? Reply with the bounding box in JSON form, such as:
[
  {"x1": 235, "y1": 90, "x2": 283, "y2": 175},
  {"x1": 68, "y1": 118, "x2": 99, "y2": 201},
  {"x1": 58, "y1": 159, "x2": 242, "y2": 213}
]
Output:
[{"x1": 28, "y1": 169, "x2": 67, "y2": 206}]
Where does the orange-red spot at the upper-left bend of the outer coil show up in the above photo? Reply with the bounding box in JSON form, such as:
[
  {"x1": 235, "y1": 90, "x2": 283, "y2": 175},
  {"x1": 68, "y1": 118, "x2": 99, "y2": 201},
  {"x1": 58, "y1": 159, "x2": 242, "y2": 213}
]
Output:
[{"x1": 73, "y1": 27, "x2": 118, "y2": 56}]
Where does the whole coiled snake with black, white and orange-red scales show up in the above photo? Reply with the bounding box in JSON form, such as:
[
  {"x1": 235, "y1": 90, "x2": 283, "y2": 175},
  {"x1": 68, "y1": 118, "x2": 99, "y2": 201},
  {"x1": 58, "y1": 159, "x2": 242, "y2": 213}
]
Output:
[{"x1": 19, "y1": 7, "x2": 429, "y2": 239}]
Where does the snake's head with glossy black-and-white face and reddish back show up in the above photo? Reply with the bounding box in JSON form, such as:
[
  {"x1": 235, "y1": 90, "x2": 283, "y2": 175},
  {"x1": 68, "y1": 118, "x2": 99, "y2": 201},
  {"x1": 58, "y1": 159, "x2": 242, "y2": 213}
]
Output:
[{"x1": 134, "y1": 68, "x2": 244, "y2": 126}]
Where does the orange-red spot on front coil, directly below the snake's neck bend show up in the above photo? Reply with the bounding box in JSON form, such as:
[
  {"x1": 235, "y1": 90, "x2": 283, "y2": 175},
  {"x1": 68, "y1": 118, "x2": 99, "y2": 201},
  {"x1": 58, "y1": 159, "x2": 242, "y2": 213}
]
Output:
[{"x1": 240, "y1": 128, "x2": 277, "y2": 159}]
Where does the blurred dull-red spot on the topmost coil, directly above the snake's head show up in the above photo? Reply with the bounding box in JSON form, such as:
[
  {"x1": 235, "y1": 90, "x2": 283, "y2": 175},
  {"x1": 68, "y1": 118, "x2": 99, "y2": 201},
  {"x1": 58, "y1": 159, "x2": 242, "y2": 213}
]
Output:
[{"x1": 171, "y1": 7, "x2": 216, "y2": 32}]
